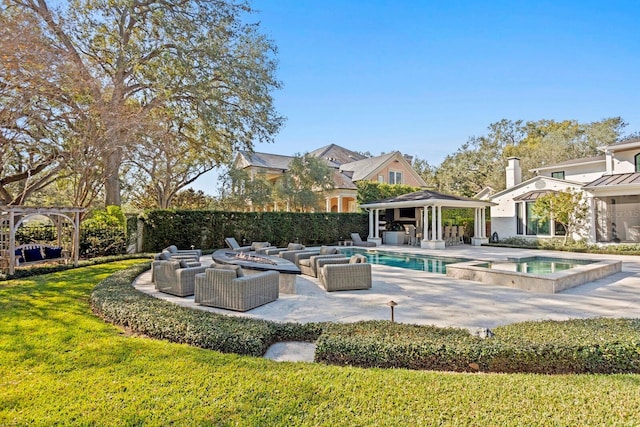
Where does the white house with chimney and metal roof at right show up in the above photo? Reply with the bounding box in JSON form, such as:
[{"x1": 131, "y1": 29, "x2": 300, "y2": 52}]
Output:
[{"x1": 485, "y1": 138, "x2": 640, "y2": 243}]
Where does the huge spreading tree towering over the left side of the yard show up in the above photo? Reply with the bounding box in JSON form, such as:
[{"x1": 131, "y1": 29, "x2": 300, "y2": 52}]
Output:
[{"x1": 3, "y1": 0, "x2": 282, "y2": 205}]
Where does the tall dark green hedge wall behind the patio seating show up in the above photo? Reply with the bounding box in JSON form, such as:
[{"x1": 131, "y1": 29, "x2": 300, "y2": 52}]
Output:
[{"x1": 139, "y1": 210, "x2": 369, "y2": 252}]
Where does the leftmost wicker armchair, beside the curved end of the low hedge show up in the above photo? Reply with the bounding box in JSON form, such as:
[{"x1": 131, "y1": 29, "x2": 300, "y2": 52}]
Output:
[{"x1": 153, "y1": 260, "x2": 206, "y2": 297}]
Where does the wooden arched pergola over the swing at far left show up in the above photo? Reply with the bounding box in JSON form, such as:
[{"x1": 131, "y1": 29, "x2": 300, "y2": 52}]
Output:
[{"x1": 0, "y1": 205, "x2": 84, "y2": 275}]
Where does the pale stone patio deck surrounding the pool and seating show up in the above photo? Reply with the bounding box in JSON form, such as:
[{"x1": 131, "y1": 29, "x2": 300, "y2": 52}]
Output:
[{"x1": 134, "y1": 245, "x2": 640, "y2": 331}]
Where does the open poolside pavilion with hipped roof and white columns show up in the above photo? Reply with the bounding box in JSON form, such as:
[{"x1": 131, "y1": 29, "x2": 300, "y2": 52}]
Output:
[{"x1": 360, "y1": 190, "x2": 495, "y2": 249}]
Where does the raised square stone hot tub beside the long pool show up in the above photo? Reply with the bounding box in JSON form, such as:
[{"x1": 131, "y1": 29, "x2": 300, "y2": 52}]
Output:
[{"x1": 447, "y1": 257, "x2": 622, "y2": 294}]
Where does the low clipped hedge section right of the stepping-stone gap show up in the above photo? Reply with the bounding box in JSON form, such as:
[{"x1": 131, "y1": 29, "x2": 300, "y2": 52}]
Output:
[{"x1": 316, "y1": 319, "x2": 640, "y2": 374}]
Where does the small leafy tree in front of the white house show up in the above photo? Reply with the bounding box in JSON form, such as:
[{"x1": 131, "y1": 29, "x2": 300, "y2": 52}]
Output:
[{"x1": 532, "y1": 190, "x2": 589, "y2": 245}]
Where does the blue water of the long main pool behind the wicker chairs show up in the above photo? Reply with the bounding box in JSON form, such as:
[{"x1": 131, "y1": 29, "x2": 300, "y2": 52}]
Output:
[{"x1": 340, "y1": 248, "x2": 470, "y2": 274}]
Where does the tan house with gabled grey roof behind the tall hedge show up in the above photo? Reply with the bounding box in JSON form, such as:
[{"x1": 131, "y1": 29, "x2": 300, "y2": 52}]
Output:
[{"x1": 233, "y1": 144, "x2": 427, "y2": 212}]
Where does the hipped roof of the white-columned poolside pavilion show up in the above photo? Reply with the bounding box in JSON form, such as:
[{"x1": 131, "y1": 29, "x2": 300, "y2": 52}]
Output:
[{"x1": 360, "y1": 190, "x2": 495, "y2": 209}]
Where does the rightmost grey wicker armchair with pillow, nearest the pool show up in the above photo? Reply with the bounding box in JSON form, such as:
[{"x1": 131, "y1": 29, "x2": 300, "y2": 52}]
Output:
[{"x1": 318, "y1": 255, "x2": 372, "y2": 292}]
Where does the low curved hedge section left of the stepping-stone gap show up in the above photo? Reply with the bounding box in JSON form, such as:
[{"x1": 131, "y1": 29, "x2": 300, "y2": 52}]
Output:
[{"x1": 91, "y1": 263, "x2": 320, "y2": 356}]
